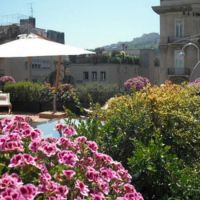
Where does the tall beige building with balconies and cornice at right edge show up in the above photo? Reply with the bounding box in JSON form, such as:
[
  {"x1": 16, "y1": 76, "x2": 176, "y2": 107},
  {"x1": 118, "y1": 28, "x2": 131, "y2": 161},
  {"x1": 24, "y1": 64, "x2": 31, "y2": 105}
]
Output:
[{"x1": 153, "y1": 0, "x2": 200, "y2": 82}]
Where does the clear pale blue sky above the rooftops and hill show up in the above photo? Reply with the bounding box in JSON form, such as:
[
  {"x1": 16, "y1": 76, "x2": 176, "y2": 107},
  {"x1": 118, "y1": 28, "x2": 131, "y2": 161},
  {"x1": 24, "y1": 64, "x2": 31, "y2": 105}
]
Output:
[{"x1": 0, "y1": 0, "x2": 160, "y2": 48}]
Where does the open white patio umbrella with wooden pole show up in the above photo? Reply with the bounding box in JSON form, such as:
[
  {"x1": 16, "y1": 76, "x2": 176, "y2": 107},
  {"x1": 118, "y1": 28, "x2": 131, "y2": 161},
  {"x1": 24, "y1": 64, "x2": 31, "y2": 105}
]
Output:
[{"x1": 0, "y1": 33, "x2": 94, "y2": 112}]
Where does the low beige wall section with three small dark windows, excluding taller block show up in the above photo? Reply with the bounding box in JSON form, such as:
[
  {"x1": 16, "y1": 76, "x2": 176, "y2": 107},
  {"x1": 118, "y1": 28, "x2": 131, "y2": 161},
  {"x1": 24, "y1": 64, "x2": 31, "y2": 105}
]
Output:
[{"x1": 69, "y1": 63, "x2": 139, "y2": 87}]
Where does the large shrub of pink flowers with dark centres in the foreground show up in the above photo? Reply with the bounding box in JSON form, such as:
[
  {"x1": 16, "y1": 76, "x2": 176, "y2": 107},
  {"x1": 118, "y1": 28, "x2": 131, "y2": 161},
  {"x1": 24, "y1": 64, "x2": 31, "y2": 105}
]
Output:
[{"x1": 0, "y1": 116, "x2": 143, "y2": 200}]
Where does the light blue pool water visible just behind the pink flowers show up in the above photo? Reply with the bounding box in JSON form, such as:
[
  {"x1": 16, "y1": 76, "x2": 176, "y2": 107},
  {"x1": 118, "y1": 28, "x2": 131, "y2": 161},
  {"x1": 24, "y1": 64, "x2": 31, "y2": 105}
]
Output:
[{"x1": 33, "y1": 119, "x2": 79, "y2": 138}]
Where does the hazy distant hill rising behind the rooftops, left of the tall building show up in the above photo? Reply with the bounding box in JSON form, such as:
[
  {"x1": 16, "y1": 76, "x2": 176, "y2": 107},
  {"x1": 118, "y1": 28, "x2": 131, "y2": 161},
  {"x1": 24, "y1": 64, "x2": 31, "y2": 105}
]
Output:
[{"x1": 102, "y1": 33, "x2": 160, "y2": 50}]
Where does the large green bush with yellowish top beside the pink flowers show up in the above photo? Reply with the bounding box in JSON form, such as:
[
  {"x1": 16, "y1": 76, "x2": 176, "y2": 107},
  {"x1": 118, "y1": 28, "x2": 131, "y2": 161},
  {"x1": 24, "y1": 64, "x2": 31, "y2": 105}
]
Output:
[{"x1": 75, "y1": 83, "x2": 200, "y2": 200}]
